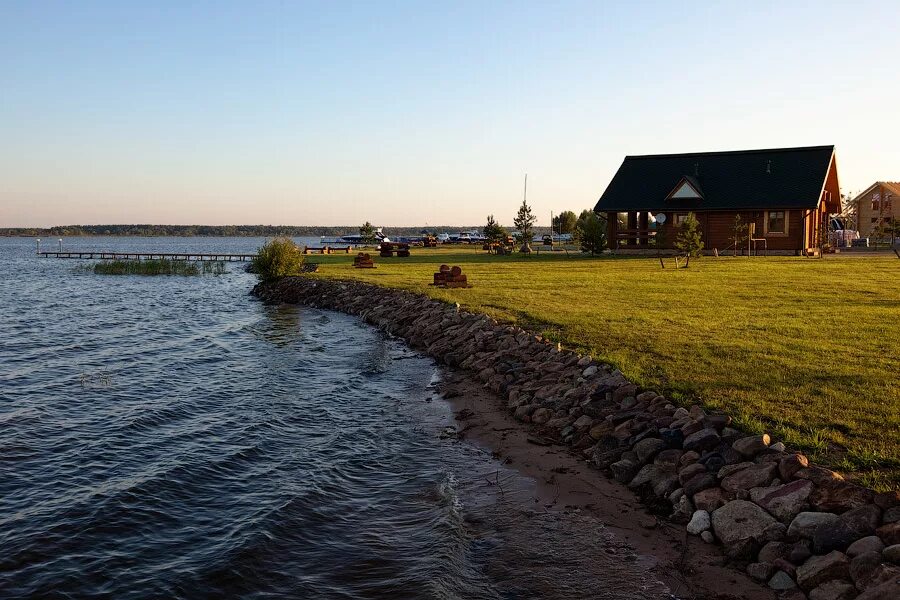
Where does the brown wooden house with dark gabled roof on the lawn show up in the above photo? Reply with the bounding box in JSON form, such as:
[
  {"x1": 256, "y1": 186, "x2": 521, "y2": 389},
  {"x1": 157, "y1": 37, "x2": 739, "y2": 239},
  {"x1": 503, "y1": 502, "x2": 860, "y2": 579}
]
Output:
[{"x1": 594, "y1": 146, "x2": 841, "y2": 254}]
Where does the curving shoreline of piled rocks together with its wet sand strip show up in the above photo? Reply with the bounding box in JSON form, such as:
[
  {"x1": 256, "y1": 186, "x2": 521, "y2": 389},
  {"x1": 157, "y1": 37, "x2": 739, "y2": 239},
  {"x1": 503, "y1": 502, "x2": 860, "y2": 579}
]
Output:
[{"x1": 252, "y1": 277, "x2": 900, "y2": 600}]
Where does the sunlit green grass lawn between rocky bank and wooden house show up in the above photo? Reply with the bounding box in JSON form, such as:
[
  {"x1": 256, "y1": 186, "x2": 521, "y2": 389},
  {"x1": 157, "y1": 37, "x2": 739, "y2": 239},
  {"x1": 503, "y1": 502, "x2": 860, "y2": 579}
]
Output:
[{"x1": 308, "y1": 248, "x2": 900, "y2": 489}]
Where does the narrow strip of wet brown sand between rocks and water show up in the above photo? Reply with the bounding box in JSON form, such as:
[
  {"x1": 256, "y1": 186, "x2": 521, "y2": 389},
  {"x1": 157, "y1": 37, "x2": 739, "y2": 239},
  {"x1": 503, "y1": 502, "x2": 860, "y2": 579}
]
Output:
[{"x1": 439, "y1": 369, "x2": 777, "y2": 600}]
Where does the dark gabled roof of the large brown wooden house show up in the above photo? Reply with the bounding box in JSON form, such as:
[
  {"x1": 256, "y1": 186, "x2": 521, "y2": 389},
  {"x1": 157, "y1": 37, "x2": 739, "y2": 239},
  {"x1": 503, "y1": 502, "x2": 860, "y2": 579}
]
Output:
[{"x1": 594, "y1": 146, "x2": 834, "y2": 212}]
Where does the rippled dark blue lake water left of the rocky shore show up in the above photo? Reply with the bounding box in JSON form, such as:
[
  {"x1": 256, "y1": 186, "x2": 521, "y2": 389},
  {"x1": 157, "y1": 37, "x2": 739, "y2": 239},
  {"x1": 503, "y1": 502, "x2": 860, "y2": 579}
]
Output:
[{"x1": 0, "y1": 238, "x2": 660, "y2": 599}]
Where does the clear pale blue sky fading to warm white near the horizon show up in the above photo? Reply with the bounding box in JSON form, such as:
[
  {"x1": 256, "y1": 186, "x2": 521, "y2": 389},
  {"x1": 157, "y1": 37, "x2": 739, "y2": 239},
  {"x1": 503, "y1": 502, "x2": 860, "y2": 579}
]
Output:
[{"x1": 0, "y1": 0, "x2": 900, "y2": 227}]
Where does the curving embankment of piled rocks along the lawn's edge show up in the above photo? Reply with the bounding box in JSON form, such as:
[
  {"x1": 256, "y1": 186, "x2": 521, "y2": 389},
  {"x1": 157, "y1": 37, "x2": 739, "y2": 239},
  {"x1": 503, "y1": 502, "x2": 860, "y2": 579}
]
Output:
[{"x1": 253, "y1": 277, "x2": 900, "y2": 600}]
